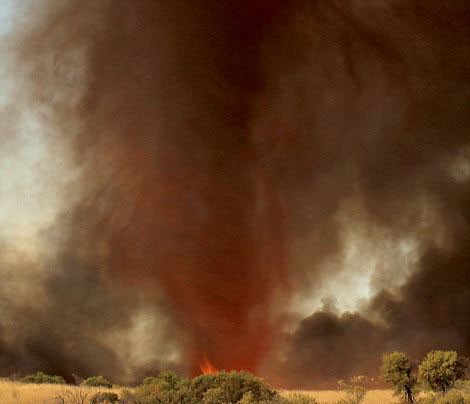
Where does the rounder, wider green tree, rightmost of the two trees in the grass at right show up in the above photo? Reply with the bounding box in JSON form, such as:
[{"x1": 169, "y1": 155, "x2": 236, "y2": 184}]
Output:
[{"x1": 419, "y1": 351, "x2": 465, "y2": 393}]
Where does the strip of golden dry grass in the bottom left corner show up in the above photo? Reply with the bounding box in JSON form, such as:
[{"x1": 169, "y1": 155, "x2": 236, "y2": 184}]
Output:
[{"x1": 0, "y1": 380, "x2": 121, "y2": 404}]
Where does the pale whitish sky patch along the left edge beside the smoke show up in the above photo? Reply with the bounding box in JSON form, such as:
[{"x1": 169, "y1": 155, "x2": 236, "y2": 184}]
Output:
[{"x1": 0, "y1": 0, "x2": 73, "y2": 250}]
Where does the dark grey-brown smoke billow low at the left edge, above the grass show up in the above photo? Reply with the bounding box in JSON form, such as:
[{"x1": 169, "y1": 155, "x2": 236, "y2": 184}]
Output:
[{"x1": 2, "y1": 243, "x2": 123, "y2": 377}]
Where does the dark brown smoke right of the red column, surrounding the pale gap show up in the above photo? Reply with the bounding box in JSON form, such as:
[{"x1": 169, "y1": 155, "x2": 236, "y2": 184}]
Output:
[{"x1": 258, "y1": 1, "x2": 470, "y2": 387}]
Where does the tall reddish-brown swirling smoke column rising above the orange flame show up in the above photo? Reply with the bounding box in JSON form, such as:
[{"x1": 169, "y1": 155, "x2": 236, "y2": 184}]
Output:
[{"x1": 63, "y1": 1, "x2": 286, "y2": 373}]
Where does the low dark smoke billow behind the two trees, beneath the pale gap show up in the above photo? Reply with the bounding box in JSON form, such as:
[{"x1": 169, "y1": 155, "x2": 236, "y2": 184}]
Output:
[{"x1": 277, "y1": 221, "x2": 470, "y2": 387}]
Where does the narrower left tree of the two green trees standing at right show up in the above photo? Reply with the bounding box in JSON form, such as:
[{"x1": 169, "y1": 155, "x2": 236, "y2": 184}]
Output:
[{"x1": 381, "y1": 352, "x2": 416, "y2": 403}]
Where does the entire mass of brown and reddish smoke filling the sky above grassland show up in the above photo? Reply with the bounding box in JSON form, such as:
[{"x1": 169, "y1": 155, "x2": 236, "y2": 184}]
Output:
[{"x1": 0, "y1": 0, "x2": 470, "y2": 387}]
